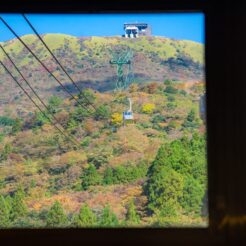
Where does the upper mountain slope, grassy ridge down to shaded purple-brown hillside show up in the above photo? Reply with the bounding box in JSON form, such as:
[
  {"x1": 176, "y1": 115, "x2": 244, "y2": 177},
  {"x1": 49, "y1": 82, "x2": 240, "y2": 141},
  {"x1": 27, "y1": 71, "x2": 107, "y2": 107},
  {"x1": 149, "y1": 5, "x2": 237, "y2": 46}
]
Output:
[{"x1": 0, "y1": 34, "x2": 204, "y2": 115}]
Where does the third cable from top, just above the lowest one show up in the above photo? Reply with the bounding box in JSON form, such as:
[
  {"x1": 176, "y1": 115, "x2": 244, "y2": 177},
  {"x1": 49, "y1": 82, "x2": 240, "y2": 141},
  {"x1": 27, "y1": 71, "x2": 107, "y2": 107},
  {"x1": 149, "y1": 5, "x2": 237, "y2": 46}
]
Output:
[{"x1": 0, "y1": 44, "x2": 79, "y2": 147}]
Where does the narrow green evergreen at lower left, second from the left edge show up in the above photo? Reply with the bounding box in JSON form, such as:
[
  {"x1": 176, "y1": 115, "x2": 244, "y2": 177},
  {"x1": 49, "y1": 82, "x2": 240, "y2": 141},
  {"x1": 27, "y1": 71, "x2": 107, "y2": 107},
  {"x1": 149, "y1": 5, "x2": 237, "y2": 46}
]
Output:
[{"x1": 10, "y1": 187, "x2": 27, "y2": 221}]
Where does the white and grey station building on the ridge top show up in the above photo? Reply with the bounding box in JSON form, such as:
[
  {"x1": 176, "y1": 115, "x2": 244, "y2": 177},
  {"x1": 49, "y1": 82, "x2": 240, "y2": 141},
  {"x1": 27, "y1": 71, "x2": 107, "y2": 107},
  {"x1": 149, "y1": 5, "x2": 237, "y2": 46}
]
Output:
[{"x1": 123, "y1": 23, "x2": 151, "y2": 38}]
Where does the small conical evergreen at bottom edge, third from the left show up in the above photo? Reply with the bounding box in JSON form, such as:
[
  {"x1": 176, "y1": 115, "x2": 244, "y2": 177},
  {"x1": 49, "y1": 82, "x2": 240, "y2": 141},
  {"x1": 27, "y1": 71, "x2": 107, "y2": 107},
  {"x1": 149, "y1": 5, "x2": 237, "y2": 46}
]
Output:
[{"x1": 46, "y1": 201, "x2": 67, "y2": 227}]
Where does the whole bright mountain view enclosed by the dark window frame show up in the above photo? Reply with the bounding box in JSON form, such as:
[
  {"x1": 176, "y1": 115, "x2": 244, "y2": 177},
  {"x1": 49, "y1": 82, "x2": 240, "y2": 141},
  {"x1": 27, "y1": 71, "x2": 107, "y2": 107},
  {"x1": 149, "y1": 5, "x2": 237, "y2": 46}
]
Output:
[{"x1": 0, "y1": 13, "x2": 208, "y2": 228}]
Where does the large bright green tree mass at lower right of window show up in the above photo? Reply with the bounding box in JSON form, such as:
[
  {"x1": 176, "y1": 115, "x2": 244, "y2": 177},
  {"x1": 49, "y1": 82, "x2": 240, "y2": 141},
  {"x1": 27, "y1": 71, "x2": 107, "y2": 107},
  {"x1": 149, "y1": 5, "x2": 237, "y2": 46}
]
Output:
[{"x1": 145, "y1": 134, "x2": 206, "y2": 216}]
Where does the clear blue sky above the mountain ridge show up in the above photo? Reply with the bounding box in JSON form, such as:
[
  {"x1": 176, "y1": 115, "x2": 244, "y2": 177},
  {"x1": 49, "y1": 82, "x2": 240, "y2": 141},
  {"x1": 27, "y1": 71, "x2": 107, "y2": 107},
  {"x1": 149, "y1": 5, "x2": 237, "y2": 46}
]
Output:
[{"x1": 0, "y1": 13, "x2": 204, "y2": 43}]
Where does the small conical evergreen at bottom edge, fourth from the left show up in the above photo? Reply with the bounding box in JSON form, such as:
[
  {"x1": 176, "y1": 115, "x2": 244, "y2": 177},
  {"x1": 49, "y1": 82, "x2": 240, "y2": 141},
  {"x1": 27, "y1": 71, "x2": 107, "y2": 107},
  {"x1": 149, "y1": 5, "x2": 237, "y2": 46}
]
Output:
[{"x1": 73, "y1": 204, "x2": 97, "y2": 227}]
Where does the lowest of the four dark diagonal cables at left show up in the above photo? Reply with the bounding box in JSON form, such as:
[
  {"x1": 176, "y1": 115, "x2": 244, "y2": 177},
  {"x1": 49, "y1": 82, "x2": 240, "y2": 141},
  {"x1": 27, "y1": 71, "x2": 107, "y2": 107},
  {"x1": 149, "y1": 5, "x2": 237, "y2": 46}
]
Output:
[{"x1": 0, "y1": 61, "x2": 80, "y2": 147}]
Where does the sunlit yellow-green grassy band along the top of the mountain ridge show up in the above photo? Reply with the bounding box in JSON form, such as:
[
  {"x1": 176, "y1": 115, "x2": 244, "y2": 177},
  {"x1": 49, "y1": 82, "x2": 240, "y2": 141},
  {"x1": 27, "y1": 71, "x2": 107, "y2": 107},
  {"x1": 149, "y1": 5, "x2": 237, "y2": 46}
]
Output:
[{"x1": 0, "y1": 34, "x2": 203, "y2": 63}]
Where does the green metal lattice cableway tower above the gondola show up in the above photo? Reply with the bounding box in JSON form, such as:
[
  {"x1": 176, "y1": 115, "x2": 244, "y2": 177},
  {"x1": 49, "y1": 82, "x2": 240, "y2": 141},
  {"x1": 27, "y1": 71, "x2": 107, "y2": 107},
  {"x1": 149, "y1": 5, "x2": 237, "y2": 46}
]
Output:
[{"x1": 109, "y1": 49, "x2": 133, "y2": 91}]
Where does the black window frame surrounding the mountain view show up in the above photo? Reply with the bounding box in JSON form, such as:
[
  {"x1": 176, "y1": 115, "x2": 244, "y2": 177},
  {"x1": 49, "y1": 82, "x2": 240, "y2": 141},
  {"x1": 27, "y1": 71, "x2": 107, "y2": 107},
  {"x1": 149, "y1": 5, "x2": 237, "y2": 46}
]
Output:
[{"x1": 0, "y1": 0, "x2": 246, "y2": 245}]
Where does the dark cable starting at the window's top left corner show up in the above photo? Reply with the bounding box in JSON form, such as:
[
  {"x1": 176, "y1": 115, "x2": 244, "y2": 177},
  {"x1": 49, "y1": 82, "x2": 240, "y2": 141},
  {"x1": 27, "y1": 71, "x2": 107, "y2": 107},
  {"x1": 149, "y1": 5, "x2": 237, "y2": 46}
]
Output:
[{"x1": 0, "y1": 16, "x2": 91, "y2": 113}]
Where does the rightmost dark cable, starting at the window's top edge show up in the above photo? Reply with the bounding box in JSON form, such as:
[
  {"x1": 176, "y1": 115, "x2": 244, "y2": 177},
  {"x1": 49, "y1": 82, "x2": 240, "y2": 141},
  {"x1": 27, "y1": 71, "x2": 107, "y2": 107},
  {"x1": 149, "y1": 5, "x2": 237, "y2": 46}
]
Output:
[{"x1": 22, "y1": 14, "x2": 96, "y2": 110}]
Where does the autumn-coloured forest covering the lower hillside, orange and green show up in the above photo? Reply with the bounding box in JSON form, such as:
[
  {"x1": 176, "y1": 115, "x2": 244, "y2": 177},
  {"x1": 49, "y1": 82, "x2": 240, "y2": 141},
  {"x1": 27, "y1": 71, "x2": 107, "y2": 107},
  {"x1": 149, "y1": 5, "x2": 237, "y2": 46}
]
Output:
[{"x1": 0, "y1": 34, "x2": 208, "y2": 228}]
